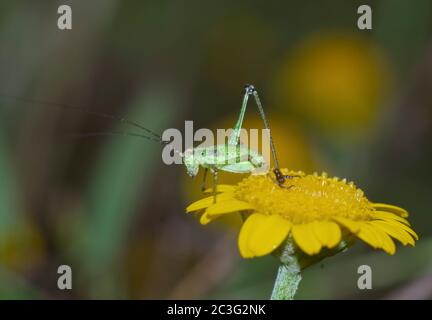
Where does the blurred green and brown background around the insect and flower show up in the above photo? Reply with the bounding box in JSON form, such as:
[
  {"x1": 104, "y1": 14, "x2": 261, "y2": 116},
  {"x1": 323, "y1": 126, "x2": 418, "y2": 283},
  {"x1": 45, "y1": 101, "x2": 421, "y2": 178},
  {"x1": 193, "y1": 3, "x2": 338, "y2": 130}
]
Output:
[{"x1": 0, "y1": 0, "x2": 432, "y2": 299}]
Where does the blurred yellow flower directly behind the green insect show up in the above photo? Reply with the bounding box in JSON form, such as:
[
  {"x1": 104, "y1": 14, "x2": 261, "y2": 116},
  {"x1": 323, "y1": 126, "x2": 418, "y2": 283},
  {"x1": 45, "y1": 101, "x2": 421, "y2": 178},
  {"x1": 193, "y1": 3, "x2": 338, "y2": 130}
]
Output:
[{"x1": 182, "y1": 114, "x2": 314, "y2": 227}]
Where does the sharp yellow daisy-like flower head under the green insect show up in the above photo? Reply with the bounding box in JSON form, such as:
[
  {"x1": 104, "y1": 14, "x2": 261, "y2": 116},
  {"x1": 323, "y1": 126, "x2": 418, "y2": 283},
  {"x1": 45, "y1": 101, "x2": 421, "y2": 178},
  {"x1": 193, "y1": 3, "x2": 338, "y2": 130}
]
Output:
[{"x1": 186, "y1": 169, "x2": 418, "y2": 258}]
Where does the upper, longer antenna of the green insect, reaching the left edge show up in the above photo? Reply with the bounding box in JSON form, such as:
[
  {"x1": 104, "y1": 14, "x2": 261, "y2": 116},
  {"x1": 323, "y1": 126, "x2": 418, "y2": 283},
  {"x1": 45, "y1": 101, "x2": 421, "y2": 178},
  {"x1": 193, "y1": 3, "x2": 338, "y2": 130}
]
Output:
[{"x1": 0, "y1": 95, "x2": 162, "y2": 140}]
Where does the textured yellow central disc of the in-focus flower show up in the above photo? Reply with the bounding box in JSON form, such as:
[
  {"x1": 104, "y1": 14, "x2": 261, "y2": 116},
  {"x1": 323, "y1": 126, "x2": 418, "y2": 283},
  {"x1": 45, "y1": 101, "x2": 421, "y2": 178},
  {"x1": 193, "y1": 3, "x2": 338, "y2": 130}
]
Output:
[{"x1": 234, "y1": 170, "x2": 374, "y2": 223}]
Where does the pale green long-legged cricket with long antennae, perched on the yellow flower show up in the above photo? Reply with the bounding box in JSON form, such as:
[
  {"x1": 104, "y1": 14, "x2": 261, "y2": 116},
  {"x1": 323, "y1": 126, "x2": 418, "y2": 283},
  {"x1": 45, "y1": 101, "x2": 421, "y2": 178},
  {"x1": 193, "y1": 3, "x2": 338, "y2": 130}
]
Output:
[{"x1": 2, "y1": 84, "x2": 292, "y2": 202}]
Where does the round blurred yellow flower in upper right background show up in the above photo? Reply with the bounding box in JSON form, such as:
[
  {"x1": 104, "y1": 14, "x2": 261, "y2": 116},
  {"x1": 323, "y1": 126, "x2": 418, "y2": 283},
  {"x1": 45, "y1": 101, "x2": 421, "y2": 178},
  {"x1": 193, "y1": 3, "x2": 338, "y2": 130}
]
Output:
[{"x1": 276, "y1": 33, "x2": 391, "y2": 133}]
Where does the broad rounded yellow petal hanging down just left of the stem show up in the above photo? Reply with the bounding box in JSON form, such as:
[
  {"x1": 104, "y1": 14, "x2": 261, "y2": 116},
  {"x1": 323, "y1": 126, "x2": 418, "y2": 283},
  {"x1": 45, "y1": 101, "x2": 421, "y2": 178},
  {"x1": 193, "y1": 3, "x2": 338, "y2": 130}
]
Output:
[{"x1": 247, "y1": 215, "x2": 292, "y2": 257}]
